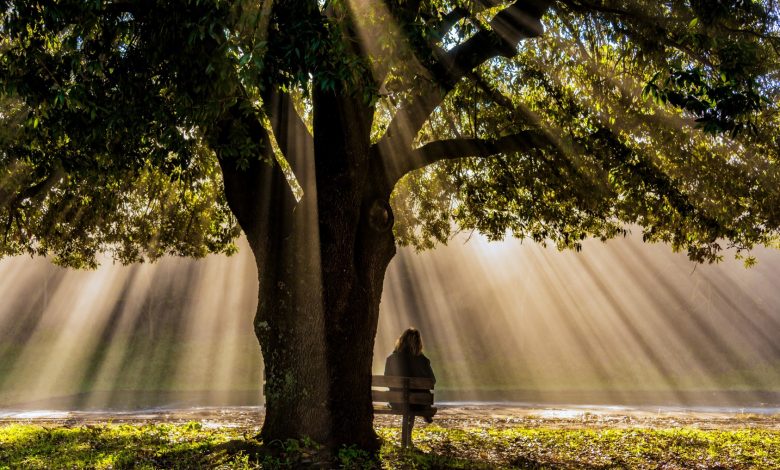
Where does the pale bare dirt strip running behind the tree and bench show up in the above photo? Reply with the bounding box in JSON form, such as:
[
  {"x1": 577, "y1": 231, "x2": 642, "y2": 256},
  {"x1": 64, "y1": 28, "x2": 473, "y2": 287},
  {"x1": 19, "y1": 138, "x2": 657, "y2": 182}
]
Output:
[{"x1": 0, "y1": 404, "x2": 780, "y2": 430}]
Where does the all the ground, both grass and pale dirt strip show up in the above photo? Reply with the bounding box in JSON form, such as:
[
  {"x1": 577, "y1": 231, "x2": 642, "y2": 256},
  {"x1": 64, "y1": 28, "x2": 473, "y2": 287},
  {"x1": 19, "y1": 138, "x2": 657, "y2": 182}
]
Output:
[{"x1": 0, "y1": 405, "x2": 780, "y2": 469}]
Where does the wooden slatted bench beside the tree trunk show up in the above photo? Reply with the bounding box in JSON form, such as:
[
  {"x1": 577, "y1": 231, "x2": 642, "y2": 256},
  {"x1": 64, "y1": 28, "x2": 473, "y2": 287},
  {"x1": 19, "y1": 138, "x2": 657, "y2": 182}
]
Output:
[{"x1": 371, "y1": 375, "x2": 436, "y2": 447}]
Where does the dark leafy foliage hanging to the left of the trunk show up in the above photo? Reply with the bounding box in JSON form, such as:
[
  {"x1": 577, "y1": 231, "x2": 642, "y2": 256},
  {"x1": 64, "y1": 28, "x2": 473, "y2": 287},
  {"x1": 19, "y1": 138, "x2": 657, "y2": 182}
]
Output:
[{"x1": 0, "y1": 2, "x2": 241, "y2": 267}]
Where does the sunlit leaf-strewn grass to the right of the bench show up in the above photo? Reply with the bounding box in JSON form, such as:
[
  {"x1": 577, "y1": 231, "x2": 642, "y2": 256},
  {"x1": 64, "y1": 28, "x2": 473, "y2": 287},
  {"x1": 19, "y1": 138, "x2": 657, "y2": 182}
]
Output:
[{"x1": 380, "y1": 426, "x2": 780, "y2": 469}]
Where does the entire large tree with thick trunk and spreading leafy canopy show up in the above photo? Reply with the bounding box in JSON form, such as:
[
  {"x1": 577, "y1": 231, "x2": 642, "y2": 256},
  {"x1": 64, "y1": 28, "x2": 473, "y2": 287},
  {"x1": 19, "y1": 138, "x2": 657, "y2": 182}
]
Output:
[{"x1": 0, "y1": 0, "x2": 780, "y2": 448}]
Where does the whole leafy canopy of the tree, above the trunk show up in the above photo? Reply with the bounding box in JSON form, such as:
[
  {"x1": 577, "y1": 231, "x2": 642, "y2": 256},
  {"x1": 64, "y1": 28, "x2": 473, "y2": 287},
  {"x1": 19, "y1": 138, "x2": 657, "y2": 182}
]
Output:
[{"x1": 0, "y1": 0, "x2": 780, "y2": 266}]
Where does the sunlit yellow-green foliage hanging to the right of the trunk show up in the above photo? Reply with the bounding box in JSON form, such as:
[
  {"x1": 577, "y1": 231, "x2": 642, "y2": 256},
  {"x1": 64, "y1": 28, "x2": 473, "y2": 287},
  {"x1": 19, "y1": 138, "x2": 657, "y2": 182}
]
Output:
[{"x1": 394, "y1": 1, "x2": 780, "y2": 262}]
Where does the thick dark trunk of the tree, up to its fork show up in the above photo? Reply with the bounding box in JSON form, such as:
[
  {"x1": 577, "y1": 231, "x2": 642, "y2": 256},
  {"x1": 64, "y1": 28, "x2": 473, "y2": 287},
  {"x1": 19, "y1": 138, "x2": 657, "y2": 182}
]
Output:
[{"x1": 218, "y1": 89, "x2": 395, "y2": 450}]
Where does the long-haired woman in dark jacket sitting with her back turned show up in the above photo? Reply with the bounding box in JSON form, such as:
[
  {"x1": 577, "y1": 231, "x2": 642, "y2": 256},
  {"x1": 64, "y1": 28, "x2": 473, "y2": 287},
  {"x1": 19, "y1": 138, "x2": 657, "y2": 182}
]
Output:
[{"x1": 385, "y1": 328, "x2": 436, "y2": 426}]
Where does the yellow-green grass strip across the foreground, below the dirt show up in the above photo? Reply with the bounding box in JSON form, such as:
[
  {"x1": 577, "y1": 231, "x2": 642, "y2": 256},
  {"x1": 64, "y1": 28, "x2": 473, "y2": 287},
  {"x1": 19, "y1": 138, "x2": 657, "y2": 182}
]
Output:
[{"x1": 0, "y1": 422, "x2": 780, "y2": 469}]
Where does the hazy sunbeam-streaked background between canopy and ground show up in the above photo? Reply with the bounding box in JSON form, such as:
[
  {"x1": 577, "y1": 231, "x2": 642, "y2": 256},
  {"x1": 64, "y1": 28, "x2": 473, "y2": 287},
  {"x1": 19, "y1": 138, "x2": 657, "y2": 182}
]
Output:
[{"x1": 0, "y1": 235, "x2": 780, "y2": 409}]
